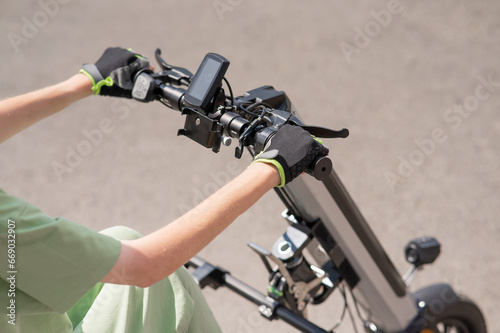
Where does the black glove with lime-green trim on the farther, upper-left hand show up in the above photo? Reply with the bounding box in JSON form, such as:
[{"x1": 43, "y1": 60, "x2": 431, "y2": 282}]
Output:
[{"x1": 80, "y1": 47, "x2": 149, "y2": 98}]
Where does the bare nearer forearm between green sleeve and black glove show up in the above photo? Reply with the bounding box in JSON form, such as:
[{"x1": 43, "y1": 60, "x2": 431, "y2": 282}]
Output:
[{"x1": 103, "y1": 163, "x2": 280, "y2": 286}]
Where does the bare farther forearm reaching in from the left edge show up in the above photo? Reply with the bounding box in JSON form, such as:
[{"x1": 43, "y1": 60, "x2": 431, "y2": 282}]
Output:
[{"x1": 0, "y1": 74, "x2": 92, "y2": 143}]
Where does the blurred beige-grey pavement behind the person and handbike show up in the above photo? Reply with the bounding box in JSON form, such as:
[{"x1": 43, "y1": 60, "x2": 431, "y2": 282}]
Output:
[{"x1": 0, "y1": 0, "x2": 500, "y2": 332}]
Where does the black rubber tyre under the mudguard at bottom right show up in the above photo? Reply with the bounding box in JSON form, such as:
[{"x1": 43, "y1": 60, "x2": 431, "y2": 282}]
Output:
[{"x1": 421, "y1": 296, "x2": 486, "y2": 333}]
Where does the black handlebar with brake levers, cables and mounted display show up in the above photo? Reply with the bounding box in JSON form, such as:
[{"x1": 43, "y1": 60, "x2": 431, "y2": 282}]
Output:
[{"x1": 132, "y1": 49, "x2": 349, "y2": 180}]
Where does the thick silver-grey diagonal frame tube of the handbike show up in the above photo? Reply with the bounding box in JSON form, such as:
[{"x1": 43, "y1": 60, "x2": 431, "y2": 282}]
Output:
[{"x1": 280, "y1": 170, "x2": 419, "y2": 332}]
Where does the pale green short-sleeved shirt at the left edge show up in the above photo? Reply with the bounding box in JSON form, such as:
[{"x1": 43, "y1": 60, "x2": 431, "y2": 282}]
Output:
[{"x1": 0, "y1": 190, "x2": 120, "y2": 332}]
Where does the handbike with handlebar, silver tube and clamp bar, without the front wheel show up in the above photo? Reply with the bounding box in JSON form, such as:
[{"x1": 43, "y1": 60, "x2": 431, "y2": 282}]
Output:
[{"x1": 132, "y1": 50, "x2": 466, "y2": 333}]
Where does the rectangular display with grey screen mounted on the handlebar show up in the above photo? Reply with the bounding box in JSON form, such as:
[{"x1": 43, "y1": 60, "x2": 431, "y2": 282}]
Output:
[{"x1": 184, "y1": 53, "x2": 229, "y2": 110}]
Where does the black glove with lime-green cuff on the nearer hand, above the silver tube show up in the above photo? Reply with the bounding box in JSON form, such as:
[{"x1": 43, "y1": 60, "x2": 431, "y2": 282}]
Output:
[{"x1": 252, "y1": 125, "x2": 328, "y2": 187}]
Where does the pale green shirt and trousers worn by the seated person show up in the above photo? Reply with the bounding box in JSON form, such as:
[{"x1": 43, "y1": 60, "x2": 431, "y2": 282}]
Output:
[{"x1": 0, "y1": 190, "x2": 220, "y2": 333}]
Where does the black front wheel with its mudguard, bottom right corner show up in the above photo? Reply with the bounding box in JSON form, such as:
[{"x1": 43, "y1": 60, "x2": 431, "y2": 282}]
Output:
[{"x1": 417, "y1": 284, "x2": 486, "y2": 333}]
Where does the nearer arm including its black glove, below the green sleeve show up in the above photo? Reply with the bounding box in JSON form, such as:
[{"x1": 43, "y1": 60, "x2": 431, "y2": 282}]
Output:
[{"x1": 102, "y1": 125, "x2": 328, "y2": 287}]
